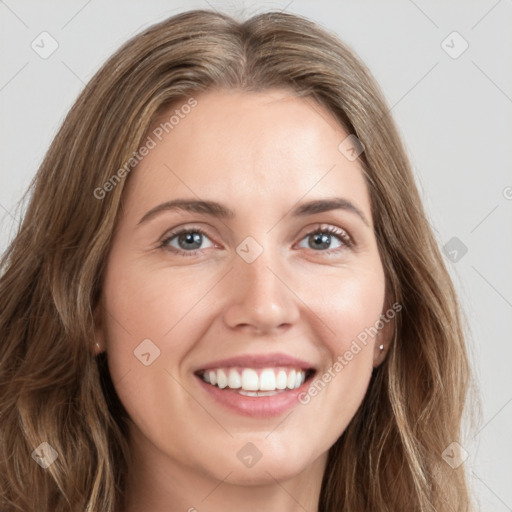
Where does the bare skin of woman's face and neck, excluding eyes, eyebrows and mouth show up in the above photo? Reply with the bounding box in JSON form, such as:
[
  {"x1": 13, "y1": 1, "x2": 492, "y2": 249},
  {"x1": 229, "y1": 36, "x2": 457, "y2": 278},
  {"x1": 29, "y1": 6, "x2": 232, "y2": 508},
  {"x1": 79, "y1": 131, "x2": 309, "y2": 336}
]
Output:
[{"x1": 96, "y1": 90, "x2": 390, "y2": 512}]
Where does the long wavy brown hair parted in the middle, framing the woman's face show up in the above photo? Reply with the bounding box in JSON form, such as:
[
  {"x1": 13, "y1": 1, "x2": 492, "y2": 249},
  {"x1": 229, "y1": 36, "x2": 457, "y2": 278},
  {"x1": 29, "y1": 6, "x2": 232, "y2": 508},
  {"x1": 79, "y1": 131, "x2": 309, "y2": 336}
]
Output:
[{"x1": 0, "y1": 10, "x2": 476, "y2": 512}]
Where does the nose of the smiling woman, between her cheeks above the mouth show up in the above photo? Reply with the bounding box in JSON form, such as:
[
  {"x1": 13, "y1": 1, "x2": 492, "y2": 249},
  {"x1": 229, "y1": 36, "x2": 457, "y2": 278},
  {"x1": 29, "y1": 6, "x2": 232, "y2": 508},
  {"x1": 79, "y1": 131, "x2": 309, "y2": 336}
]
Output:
[{"x1": 224, "y1": 245, "x2": 300, "y2": 334}]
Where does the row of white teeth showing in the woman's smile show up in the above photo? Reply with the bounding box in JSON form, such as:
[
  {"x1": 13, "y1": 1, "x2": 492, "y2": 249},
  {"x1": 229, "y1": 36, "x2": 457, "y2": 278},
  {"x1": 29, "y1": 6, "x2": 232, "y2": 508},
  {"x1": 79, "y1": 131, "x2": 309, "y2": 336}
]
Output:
[{"x1": 202, "y1": 368, "x2": 306, "y2": 396}]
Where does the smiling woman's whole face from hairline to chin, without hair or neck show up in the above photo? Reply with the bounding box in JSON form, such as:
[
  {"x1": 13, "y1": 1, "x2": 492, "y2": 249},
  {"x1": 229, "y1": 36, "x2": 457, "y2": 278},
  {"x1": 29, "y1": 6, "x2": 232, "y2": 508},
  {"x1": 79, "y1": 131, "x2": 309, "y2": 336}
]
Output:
[{"x1": 98, "y1": 90, "x2": 386, "y2": 484}]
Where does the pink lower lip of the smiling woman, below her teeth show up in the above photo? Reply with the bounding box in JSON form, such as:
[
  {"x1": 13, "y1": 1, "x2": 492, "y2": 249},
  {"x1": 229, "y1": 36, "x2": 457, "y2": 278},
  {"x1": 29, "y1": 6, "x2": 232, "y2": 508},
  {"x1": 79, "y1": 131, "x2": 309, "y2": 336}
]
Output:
[{"x1": 195, "y1": 375, "x2": 311, "y2": 418}]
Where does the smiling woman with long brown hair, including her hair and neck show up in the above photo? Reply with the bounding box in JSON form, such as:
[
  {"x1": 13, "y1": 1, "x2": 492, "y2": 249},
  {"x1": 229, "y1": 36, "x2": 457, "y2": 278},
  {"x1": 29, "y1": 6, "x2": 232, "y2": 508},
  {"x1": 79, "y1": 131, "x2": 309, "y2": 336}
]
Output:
[{"x1": 0, "y1": 10, "x2": 480, "y2": 512}]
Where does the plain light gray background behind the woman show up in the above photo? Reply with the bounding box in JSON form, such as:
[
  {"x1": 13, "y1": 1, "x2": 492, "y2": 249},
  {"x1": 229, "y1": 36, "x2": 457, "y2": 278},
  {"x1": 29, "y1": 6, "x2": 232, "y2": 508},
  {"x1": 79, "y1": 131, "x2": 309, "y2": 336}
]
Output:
[{"x1": 0, "y1": 0, "x2": 512, "y2": 512}]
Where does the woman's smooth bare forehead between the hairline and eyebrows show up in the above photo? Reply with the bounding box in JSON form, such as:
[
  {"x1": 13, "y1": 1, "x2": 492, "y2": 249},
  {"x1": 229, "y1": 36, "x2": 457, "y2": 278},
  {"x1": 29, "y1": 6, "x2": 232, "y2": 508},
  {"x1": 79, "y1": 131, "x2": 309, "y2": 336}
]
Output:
[{"x1": 126, "y1": 90, "x2": 371, "y2": 222}]
